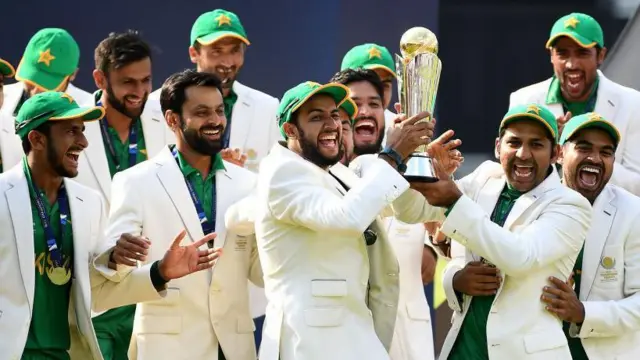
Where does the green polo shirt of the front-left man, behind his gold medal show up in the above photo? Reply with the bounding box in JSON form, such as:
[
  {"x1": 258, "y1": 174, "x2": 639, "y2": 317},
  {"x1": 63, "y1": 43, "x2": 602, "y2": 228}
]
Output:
[{"x1": 22, "y1": 158, "x2": 73, "y2": 360}]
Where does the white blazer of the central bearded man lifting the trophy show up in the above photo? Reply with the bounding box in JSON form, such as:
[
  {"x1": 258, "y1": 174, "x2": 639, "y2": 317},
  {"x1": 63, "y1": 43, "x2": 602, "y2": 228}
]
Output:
[{"x1": 255, "y1": 144, "x2": 409, "y2": 360}]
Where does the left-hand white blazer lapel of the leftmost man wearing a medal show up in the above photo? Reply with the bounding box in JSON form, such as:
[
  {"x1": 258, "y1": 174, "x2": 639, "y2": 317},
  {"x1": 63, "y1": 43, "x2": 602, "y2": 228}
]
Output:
[{"x1": 5, "y1": 165, "x2": 35, "y2": 308}]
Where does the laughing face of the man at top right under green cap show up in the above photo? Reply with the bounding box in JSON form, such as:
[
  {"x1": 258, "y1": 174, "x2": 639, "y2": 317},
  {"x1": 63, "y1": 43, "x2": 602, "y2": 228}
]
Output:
[{"x1": 551, "y1": 36, "x2": 607, "y2": 102}]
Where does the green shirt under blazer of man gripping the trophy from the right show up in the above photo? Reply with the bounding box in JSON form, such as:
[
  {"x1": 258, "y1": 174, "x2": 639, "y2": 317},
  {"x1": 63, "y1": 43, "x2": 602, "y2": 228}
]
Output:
[{"x1": 448, "y1": 186, "x2": 522, "y2": 360}]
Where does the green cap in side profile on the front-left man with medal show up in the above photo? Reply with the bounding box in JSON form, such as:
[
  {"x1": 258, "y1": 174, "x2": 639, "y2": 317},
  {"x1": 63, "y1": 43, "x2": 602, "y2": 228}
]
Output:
[{"x1": 16, "y1": 91, "x2": 104, "y2": 139}]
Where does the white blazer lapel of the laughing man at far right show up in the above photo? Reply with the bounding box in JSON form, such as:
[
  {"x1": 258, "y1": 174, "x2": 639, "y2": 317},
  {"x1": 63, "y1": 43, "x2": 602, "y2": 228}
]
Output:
[{"x1": 580, "y1": 187, "x2": 618, "y2": 300}]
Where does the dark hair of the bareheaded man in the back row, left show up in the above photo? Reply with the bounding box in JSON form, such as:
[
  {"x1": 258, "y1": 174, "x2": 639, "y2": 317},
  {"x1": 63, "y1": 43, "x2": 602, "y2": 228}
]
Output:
[{"x1": 94, "y1": 30, "x2": 151, "y2": 74}]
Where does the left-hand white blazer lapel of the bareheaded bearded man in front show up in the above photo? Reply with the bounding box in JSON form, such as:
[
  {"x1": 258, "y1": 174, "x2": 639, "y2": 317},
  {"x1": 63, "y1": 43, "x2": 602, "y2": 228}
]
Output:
[{"x1": 155, "y1": 147, "x2": 205, "y2": 241}]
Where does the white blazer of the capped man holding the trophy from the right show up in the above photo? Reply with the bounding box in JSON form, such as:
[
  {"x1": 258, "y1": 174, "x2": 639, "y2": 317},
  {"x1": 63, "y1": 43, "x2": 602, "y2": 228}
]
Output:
[{"x1": 394, "y1": 161, "x2": 591, "y2": 360}]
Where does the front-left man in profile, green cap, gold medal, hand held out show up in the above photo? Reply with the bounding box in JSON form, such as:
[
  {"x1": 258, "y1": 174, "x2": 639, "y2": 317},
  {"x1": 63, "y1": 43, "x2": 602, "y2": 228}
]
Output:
[{"x1": 0, "y1": 92, "x2": 217, "y2": 360}]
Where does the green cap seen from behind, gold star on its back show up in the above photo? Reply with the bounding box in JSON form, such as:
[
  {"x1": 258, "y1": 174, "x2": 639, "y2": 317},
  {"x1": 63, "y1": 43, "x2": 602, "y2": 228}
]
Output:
[{"x1": 16, "y1": 28, "x2": 80, "y2": 91}]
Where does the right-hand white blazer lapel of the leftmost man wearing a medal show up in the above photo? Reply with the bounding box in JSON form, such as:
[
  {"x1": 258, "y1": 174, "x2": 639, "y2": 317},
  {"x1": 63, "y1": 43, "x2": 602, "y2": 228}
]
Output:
[{"x1": 65, "y1": 180, "x2": 94, "y2": 311}]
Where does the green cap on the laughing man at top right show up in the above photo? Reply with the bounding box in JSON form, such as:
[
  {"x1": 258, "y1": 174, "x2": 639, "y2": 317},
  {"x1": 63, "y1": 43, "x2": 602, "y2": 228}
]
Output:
[{"x1": 546, "y1": 13, "x2": 604, "y2": 49}]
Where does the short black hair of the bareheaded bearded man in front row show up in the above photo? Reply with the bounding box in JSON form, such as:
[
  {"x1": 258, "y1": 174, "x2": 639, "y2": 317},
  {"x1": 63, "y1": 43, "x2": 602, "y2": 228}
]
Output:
[{"x1": 160, "y1": 69, "x2": 222, "y2": 114}]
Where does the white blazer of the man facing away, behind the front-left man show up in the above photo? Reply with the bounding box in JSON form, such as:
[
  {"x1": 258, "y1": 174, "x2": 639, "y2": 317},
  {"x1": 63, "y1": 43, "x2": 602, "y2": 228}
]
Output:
[{"x1": 0, "y1": 82, "x2": 91, "y2": 171}]
